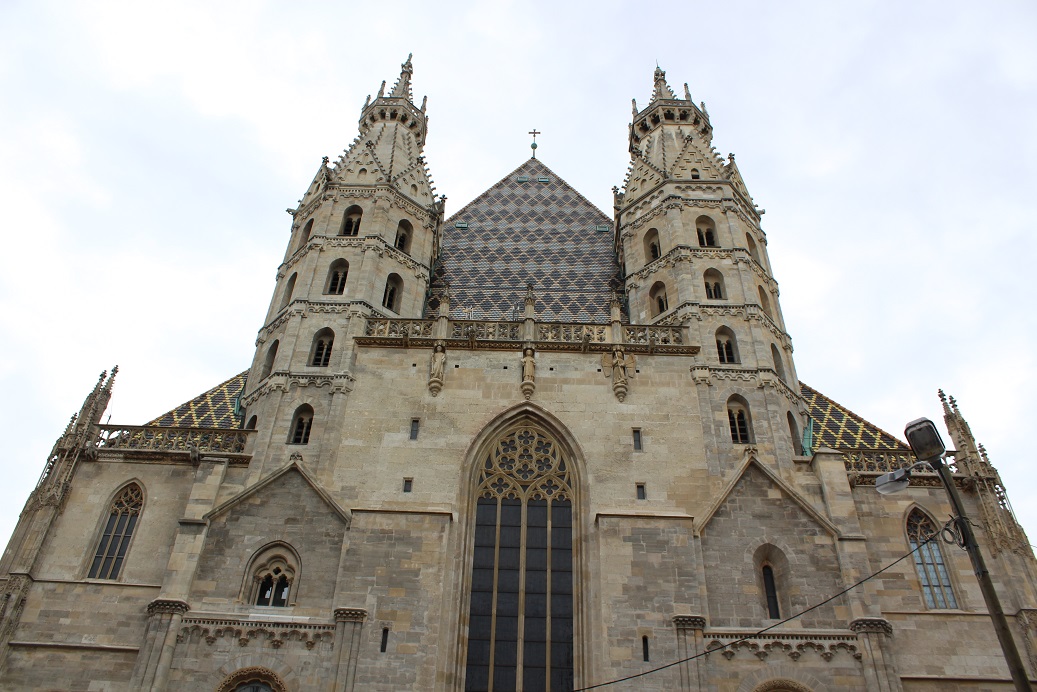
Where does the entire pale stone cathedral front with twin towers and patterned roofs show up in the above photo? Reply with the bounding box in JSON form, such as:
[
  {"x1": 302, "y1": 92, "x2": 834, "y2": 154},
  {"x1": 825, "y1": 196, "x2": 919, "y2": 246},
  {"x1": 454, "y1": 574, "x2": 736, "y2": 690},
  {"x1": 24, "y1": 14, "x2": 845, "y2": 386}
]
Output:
[{"x1": 0, "y1": 58, "x2": 1037, "y2": 692}]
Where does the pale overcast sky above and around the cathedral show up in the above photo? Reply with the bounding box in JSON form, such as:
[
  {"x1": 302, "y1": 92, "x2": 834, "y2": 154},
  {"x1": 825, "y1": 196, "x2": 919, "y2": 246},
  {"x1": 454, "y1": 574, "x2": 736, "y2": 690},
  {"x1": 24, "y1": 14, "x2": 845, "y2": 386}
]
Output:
[{"x1": 0, "y1": 0, "x2": 1037, "y2": 556}]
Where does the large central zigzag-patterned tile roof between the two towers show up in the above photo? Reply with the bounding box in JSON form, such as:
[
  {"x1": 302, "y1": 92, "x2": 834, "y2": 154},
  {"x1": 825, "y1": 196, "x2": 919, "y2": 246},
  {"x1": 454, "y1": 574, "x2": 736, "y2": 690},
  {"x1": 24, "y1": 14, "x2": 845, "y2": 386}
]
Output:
[{"x1": 429, "y1": 159, "x2": 621, "y2": 323}]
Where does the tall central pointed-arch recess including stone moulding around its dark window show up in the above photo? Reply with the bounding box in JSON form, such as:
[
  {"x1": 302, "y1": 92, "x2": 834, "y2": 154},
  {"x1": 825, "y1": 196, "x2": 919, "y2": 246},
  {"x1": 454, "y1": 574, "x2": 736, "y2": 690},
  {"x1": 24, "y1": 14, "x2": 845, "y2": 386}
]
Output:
[{"x1": 455, "y1": 403, "x2": 588, "y2": 689}]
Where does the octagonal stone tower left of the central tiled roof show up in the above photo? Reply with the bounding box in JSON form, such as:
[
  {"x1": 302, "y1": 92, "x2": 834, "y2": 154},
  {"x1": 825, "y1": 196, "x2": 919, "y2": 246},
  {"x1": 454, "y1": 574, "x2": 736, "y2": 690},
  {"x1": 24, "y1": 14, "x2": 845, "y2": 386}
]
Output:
[{"x1": 242, "y1": 56, "x2": 446, "y2": 479}]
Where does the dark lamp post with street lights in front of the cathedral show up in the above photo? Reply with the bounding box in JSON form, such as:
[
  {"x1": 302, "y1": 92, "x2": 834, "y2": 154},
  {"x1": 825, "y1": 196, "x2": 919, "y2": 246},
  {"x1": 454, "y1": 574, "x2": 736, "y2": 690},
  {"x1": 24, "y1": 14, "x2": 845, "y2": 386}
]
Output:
[{"x1": 875, "y1": 418, "x2": 1033, "y2": 692}]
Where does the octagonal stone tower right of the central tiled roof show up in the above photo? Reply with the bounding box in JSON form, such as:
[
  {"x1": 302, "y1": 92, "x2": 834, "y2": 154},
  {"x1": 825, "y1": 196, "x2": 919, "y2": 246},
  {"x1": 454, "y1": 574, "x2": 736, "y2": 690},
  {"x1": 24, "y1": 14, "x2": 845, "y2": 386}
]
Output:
[{"x1": 614, "y1": 67, "x2": 808, "y2": 468}]
